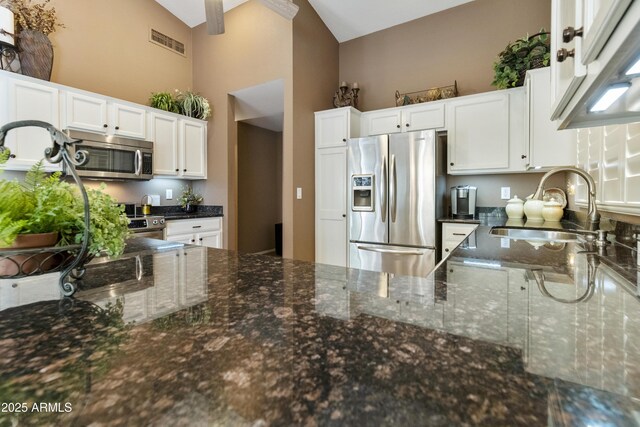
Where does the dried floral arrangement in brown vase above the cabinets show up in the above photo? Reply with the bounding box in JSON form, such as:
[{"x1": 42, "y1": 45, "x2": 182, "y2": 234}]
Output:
[{"x1": 0, "y1": 0, "x2": 64, "y2": 35}]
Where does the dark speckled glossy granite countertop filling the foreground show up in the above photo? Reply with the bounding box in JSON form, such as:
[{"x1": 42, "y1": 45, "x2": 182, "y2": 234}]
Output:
[{"x1": 0, "y1": 231, "x2": 640, "y2": 426}]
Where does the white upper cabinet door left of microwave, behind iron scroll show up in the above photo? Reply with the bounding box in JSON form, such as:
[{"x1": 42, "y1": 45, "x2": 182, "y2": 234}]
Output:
[{"x1": 0, "y1": 79, "x2": 62, "y2": 171}]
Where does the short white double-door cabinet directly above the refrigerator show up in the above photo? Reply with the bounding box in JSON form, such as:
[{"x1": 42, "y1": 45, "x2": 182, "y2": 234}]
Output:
[{"x1": 362, "y1": 102, "x2": 445, "y2": 135}]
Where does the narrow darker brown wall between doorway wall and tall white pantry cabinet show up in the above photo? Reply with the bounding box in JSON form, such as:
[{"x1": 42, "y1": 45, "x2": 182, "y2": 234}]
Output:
[{"x1": 293, "y1": 0, "x2": 339, "y2": 261}]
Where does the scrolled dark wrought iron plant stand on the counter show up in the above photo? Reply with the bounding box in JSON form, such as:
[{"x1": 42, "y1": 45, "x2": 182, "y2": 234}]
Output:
[{"x1": 0, "y1": 120, "x2": 90, "y2": 296}]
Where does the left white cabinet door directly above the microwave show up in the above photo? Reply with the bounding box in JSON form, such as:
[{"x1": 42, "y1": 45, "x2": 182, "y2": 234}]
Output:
[{"x1": 62, "y1": 91, "x2": 108, "y2": 133}]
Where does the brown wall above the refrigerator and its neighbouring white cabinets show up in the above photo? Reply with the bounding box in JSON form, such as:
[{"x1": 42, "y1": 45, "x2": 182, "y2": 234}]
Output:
[{"x1": 334, "y1": 0, "x2": 551, "y2": 111}]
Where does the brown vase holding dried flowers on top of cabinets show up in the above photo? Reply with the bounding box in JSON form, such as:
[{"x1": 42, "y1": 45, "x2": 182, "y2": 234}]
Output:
[{"x1": 17, "y1": 30, "x2": 53, "y2": 80}]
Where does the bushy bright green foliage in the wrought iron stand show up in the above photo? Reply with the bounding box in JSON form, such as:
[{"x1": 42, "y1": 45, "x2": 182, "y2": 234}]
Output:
[{"x1": 0, "y1": 159, "x2": 129, "y2": 275}]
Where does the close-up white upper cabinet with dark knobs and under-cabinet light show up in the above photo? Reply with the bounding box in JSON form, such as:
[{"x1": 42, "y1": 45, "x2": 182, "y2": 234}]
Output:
[{"x1": 551, "y1": 0, "x2": 640, "y2": 129}]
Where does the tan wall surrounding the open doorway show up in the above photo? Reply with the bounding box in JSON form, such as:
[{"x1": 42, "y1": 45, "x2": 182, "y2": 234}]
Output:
[{"x1": 193, "y1": 2, "x2": 293, "y2": 252}]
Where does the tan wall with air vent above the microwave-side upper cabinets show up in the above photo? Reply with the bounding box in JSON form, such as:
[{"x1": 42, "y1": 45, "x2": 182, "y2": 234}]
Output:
[{"x1": 50, "y1": 0, "x2": 193, "y2": 104}]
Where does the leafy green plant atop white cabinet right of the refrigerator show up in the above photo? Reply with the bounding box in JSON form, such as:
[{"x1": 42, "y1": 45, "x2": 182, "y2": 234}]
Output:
[{"x1": 491, "y1": 29, "x2": 551, "y2": 89}]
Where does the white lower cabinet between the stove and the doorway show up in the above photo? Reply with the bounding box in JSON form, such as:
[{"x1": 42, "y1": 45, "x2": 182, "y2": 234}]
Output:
[{"x1": 164, "y1": 218, "x2": 224, "y2": 249}]
